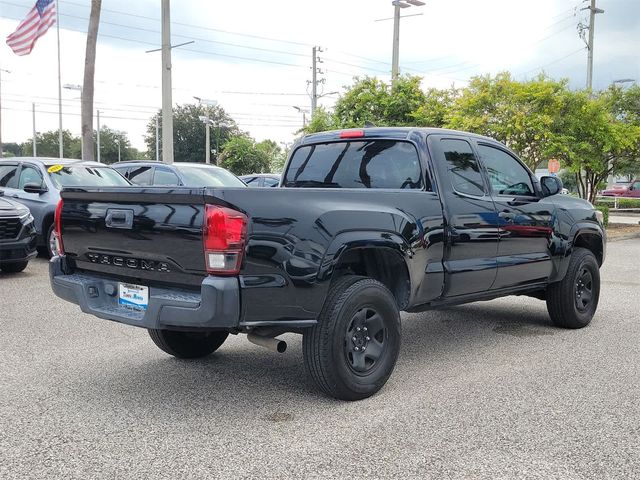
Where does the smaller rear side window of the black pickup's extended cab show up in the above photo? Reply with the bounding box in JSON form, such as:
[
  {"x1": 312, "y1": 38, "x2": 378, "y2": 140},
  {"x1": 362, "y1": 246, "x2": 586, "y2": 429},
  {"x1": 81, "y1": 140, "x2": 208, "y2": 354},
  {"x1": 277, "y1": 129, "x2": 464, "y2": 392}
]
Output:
[{"x1": 440, "y1": 139, "x2": 485, "y2": 197}]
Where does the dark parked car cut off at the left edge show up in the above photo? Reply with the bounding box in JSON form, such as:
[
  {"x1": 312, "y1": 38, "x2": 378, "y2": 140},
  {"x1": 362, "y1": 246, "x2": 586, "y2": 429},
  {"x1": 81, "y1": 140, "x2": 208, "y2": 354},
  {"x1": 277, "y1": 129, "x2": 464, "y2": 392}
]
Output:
[{"x1": 0, "y1": 192, "x2": 37, "y2": 273}]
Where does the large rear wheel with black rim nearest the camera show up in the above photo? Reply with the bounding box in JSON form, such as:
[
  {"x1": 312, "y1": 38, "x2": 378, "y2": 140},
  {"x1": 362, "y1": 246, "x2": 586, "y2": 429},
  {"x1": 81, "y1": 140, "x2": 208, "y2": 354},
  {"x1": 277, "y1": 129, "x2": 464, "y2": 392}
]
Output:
[{"x1": 302, "y1": 276, "x2": 401, "y2": 400}]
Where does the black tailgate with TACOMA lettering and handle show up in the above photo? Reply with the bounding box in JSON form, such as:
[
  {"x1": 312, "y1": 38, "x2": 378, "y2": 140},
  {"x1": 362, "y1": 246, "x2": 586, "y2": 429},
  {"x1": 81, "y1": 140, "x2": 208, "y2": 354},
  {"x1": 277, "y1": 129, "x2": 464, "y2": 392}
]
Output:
[{"x1": 61, "y1": 187, "x2": 206, "y2": 287}]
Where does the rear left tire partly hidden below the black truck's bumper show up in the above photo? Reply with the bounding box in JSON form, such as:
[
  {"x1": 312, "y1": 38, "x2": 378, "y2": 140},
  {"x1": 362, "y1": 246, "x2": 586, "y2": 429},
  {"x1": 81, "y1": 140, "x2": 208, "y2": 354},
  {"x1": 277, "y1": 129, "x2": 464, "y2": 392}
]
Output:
[{"x1": 148, "y1": 328, "x2": 229, "y2": 358}]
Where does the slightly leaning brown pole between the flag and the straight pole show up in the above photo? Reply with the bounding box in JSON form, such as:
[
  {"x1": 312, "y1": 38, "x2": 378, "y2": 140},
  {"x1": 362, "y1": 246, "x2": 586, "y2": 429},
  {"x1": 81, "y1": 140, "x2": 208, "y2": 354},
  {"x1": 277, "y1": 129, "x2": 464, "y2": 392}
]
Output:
[{"x1": 80, "y1": 0, "x2": 102, "y2": 160}]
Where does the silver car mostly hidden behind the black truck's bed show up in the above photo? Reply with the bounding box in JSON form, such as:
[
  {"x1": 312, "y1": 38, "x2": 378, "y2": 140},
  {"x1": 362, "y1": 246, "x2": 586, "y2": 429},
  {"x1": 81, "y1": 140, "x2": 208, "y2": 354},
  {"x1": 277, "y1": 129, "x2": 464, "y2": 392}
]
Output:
[{"x1": 113, "y1": 161, "x2": 246, "y2": 187}]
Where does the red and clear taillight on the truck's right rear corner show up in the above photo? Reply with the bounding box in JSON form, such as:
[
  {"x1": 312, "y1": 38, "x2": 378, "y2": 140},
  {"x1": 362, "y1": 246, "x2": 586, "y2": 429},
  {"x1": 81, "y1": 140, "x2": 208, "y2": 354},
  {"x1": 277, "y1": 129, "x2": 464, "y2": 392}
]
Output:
[{"x1": 203, "y1": 205, "x2": 247, "y2": 275}]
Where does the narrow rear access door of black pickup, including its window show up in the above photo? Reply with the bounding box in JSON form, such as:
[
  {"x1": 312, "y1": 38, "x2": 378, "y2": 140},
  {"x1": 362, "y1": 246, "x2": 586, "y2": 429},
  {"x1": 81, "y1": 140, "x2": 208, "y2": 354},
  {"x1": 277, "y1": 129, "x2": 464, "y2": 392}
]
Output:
[{"x1": 428, "y1": 135, "x2": 498, "y2": 297}]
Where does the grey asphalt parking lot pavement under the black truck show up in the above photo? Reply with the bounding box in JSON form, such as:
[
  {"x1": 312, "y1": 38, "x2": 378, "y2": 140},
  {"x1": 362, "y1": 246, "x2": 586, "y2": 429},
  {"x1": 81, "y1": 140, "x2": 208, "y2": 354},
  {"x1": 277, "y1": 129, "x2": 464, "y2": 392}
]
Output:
[{"x1": 0, "y1": 240, "x2": 640, "y2": 480}]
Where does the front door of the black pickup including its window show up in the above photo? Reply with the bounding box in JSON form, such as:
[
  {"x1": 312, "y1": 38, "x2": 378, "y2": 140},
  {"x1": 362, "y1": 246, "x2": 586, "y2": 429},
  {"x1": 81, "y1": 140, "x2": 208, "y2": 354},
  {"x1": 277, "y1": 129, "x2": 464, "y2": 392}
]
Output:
[{"x1": 477, "y1": 142, "x2": 555, "y2": 288}]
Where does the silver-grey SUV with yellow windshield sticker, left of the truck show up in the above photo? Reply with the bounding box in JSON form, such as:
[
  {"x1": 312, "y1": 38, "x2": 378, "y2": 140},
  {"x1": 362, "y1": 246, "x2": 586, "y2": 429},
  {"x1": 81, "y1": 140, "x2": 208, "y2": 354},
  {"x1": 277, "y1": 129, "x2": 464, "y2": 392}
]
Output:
[{"x1": 0, "y1": 157, "x2": 130, "y2": 256}]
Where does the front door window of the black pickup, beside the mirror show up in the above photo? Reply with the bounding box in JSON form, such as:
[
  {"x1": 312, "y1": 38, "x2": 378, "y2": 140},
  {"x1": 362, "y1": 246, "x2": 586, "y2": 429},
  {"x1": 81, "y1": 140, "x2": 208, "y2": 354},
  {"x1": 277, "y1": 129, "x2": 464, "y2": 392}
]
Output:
[{"x1": 478, "y1": 144, "x2": 535, "y2": 196}]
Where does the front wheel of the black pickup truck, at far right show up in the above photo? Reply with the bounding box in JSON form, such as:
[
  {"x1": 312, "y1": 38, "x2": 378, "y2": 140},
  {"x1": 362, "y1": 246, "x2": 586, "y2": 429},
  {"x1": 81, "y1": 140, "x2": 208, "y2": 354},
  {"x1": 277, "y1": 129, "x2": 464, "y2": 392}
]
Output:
[{"x1": 547, "y1": 248, "x2": 600, "y2": 328}]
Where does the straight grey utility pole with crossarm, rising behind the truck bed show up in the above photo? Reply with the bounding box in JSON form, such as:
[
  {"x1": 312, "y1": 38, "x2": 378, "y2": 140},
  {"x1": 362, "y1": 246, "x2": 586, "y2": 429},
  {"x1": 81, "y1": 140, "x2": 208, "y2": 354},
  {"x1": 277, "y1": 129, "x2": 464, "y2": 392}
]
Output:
[{"x1": 162, "y1": 0, "x2": 173, "y2": 164}]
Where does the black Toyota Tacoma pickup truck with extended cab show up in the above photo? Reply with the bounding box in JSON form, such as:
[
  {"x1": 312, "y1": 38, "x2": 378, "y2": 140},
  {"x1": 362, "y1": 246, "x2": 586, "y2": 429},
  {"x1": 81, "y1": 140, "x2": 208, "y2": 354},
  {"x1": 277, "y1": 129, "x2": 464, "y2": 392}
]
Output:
[{"x1": 50, "y1": 128, "x2": 605, "y2": 400}]
